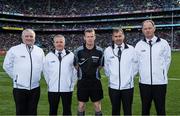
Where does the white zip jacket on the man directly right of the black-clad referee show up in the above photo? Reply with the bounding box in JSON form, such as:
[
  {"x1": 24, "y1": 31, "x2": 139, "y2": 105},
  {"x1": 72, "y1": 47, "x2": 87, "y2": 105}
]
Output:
[{"x1": 104, "y1": 44, "x2": 137, "y2": 90}]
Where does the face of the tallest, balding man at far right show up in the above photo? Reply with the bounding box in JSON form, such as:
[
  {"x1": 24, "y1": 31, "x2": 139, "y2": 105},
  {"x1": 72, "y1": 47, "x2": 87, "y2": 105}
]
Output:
[{"x1": 142, "y1": 22, "x2": 155, "y2": 39}]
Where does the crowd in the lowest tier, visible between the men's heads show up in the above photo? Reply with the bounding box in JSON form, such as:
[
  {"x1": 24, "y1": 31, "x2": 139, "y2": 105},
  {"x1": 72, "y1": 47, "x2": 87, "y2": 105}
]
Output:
[{"x1": 0, "y1": 30, "x2": 180, "y2": 52}]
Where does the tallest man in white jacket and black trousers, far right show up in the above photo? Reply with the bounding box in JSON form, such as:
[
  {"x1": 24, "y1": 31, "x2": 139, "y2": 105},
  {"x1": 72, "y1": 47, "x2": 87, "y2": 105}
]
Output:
[{"x1": 135, "y1": 20, "x2": 171, "y2": 115}]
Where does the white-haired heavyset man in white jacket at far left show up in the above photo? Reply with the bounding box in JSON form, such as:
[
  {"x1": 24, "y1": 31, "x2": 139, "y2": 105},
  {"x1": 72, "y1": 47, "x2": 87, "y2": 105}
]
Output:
[{"x1": 3, "y1": 29, "x2": 44, "y2": 115}]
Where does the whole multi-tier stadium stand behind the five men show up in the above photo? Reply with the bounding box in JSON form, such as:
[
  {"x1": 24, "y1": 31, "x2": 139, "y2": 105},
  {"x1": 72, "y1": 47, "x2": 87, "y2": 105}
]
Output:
[{"x1": 0, "y1": 0, "x2": 180, "y2": 52}]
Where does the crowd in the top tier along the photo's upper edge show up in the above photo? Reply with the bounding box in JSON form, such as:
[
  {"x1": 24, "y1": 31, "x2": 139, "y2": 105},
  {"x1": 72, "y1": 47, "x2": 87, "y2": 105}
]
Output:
[{"x1": 0, "y1": 0, "x2": 180, "y2": 16}]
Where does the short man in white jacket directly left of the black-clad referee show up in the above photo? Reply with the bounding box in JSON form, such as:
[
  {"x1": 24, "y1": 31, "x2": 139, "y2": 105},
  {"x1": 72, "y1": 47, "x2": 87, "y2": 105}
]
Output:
[{"x1": 43, "y1": 35, "x2": 77, "y2": 115}]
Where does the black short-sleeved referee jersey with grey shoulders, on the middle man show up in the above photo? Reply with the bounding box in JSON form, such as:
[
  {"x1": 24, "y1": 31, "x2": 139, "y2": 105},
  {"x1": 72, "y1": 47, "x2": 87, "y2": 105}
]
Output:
[{"x1": 75, "y1": 44, "x2": 103, "y2": 80}]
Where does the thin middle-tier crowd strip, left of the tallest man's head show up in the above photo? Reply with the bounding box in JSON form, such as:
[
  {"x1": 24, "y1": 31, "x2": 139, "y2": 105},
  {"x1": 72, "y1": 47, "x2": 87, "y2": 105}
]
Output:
[{"x1": 1, "y1": 22, "x2": 134, "y2": 30}]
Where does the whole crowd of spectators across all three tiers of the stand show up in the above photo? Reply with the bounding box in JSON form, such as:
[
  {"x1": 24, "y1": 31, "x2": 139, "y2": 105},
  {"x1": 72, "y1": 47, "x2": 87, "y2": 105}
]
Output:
[{"x1": 0, "y1": 0, "x2": 180, "y2": 52}]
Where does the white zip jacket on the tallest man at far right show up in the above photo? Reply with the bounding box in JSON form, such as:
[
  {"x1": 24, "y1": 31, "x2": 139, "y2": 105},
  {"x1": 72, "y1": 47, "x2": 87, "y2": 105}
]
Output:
[{"x1": 135, "y1": 36, "x2": 171, "y2": 85}]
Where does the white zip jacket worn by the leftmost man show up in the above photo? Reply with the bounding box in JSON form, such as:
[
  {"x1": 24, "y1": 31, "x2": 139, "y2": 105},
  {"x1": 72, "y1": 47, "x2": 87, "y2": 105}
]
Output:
[{"x1": 3, "y1": 44, "x2": 44, "y2": 90}]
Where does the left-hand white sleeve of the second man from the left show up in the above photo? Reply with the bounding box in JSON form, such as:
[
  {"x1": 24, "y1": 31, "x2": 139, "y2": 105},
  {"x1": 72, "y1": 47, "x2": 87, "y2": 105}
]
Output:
[{"x1": 43, "y1": 57, "x2": 50, "y2": 84}]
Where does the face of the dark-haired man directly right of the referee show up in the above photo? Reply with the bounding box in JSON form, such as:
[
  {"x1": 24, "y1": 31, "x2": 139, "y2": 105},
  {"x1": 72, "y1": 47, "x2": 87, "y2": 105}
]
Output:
[{"x1": 112, "y1": 31, "x2": 124, "y2": 45}]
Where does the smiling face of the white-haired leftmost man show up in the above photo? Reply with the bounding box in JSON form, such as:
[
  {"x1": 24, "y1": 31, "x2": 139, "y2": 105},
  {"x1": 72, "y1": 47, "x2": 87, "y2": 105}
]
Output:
[{"x1": 22, "y1": 31, "x2": 35, "y2": 46}]
